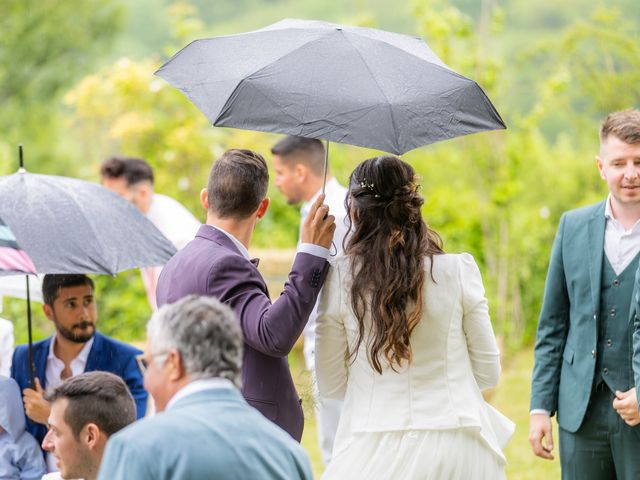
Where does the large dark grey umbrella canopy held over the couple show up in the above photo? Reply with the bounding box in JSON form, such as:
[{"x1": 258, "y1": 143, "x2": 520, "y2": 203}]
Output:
[{"x1": 156, "y1": 19, "x2": 505, "y2": 154}]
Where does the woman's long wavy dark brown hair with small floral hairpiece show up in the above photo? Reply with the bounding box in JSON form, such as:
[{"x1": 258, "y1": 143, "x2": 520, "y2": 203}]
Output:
[{"x1": 345, "y1": 155, "x2": 444, "y2": 373}]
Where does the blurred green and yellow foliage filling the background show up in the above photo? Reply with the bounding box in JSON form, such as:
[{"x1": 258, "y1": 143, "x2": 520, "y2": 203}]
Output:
[{"x1": 0, "y1": 0, "x2": 640, "y2": 349}]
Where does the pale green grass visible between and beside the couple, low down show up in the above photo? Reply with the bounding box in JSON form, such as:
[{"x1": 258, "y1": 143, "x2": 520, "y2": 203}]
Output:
[{"x1": 252, "y1": 250, "x2": 560, "y2": 480}]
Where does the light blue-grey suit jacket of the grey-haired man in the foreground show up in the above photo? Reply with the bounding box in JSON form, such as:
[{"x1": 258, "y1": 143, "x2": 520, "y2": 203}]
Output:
[{"x1": 98, "y1": 388, "x2": 313, "y2": 480}]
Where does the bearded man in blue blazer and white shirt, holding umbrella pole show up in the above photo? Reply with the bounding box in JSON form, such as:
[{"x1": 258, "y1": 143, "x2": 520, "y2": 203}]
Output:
[{"x1": 11, "y1": 275, "x2": 147, "y2": 471}]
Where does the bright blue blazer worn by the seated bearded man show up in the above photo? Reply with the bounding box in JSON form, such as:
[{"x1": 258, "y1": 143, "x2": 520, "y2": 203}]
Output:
[{"x1": 11, "y1": 332, "x2": 147, "y2": 444}]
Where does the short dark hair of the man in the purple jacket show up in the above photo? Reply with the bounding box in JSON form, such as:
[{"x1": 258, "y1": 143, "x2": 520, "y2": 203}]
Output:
[{"x1": 207, "y1": 149, "x2": 269, "y2": 219}]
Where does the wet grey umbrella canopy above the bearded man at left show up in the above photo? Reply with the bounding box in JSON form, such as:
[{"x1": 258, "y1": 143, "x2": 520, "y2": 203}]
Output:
[{"x1": 0, "y1": 171, "x2": 176, "y2": 275}]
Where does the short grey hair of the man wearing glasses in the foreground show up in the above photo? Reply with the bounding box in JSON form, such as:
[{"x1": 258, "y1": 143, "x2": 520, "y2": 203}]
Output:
[{"x1": 147, "y1": 295, "x2": 243, "y2": 388}]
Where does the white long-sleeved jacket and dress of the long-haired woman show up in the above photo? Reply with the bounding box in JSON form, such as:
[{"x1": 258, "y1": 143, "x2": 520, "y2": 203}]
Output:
[{"x1": 316, "y1": 254, "x2": 514, "y2": 480}]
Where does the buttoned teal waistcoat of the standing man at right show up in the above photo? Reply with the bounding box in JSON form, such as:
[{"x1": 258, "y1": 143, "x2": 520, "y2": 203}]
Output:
[{"x1": 595, "y1": 254, "x2": 640, "y2": 392}]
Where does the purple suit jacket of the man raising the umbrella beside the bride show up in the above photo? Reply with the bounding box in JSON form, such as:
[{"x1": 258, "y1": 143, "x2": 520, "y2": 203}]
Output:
[{"x1": 156, "y1": 225, "x2": 329, "y2": 441}]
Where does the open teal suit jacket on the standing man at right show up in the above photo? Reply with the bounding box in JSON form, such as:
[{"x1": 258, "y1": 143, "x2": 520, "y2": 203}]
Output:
[{"x1": 531, "y1": 201, "x2": 640, "y2": 432}]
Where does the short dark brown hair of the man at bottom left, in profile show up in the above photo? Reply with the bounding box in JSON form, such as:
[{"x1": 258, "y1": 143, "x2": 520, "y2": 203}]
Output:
[{"x1": 46, "y1": 372, "x2": 136, "y2": 438}]
